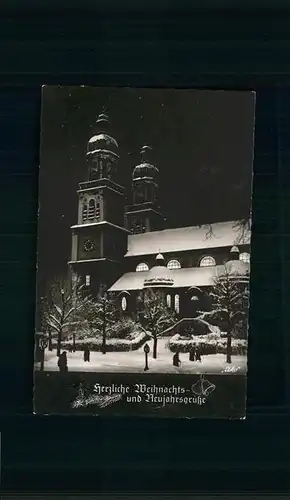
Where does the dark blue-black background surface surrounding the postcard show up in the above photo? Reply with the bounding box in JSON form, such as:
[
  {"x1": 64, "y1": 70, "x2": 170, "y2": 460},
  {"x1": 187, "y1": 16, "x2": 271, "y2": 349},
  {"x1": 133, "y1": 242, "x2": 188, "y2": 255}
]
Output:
[{"x1": 0, "y1": 0, "x2": 290, "y2": 498}]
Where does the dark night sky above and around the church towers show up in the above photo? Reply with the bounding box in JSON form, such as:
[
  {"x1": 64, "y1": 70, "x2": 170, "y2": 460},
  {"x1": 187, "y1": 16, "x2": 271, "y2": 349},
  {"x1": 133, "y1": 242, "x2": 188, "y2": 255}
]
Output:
[{"x1": 38, "y1": 87, "x2": 254, "y2": 290}]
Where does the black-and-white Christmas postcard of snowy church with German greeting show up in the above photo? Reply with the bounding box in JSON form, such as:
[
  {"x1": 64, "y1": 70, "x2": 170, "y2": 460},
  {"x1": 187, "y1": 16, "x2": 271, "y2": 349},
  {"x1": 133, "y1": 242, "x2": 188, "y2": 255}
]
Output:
[{"x1": 34, "y1": 86, "x2": 255, "y2": 418}]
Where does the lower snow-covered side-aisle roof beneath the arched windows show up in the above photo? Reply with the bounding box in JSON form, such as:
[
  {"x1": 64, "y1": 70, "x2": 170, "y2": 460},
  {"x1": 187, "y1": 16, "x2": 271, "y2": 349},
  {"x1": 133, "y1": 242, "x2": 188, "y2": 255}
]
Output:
[{"x1": 109, "y1": 261, "x2": 250, "y2": 292}]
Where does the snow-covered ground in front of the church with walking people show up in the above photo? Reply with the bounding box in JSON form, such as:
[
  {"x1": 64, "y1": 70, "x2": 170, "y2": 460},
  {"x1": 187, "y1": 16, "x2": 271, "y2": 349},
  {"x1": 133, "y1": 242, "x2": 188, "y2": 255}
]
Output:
[{"x1": 35, "y1": 338, "x2": 247, "y2": 374}]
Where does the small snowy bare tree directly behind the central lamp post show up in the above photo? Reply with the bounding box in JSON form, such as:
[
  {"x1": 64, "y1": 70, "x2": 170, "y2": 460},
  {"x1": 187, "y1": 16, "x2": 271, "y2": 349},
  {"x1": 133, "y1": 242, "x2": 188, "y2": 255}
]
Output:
[{"x1": 137, "y1": 289, "x2": 177, "y2": 359}]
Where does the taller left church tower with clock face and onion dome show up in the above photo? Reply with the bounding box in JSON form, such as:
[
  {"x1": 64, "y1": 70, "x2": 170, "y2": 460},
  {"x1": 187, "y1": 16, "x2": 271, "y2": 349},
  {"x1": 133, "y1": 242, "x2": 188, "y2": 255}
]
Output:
[{"x1": 69, "y1": 113, "x2": 128, "y2": 295}]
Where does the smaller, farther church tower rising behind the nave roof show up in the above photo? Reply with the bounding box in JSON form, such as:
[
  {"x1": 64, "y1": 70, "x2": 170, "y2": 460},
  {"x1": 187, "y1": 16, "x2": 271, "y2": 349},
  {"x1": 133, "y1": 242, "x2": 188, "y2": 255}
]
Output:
[{"x1": 125, "y1": 146, "x2": 164, "y2": 234}]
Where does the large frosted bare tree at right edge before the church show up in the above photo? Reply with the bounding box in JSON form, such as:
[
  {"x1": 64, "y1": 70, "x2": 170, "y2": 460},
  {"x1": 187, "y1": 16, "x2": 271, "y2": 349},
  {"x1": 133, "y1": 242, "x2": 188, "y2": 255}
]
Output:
[{"x1": 199, "y1": 265, "x2": 249, "y2": 363}]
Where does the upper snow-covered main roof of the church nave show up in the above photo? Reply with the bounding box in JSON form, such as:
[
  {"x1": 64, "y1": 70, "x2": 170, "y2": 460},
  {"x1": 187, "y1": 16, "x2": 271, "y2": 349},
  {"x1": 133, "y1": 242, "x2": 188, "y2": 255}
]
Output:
[{"x1": 125, "y1": 221, "x2": 250, "y2": 257}]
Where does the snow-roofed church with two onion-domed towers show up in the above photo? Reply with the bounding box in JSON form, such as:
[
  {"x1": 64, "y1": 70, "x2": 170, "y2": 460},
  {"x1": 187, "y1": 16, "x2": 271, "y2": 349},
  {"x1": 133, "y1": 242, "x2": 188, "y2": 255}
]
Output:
[{"x1": 69, "y1": 113, "x2": 250, "y2": 318}]
